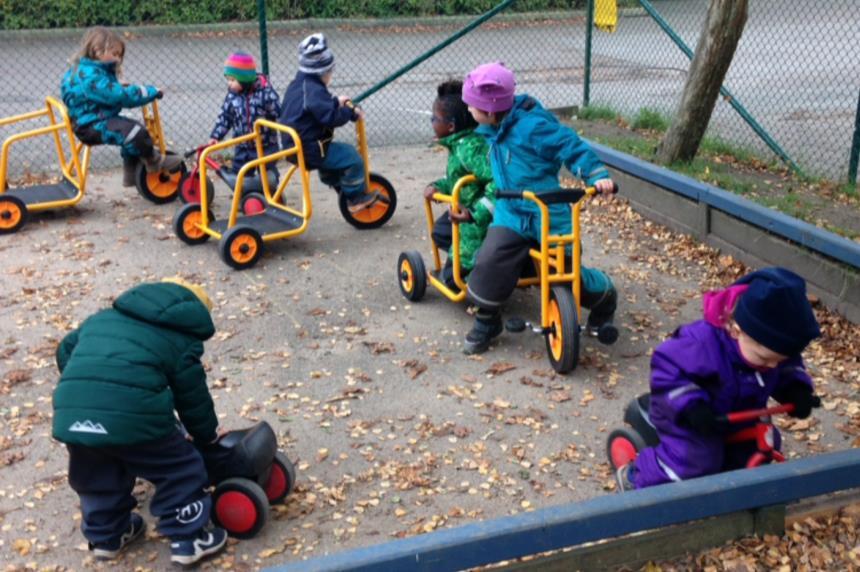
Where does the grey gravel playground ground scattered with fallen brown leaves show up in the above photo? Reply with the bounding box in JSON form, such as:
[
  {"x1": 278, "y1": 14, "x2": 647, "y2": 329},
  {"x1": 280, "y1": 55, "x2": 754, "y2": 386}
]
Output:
[{"x1": 0, "y1": 147, "x2": 860, "y2": 570}]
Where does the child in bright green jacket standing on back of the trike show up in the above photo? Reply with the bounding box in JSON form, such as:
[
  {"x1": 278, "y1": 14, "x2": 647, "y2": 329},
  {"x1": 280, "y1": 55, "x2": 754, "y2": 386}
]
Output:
[{"x1": 424, "y1": 80, "x2": 495, "y2": 288}]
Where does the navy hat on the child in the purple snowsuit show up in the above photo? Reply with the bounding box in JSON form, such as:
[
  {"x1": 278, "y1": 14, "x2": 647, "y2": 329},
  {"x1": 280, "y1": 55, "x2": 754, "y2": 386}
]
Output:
[{"x1": 734, "y1": 268, "x2": 821, "y2": 357}]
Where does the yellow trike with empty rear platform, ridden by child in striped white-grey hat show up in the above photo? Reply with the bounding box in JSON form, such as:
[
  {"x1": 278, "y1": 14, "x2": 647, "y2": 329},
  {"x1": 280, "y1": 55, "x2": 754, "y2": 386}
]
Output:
[{"x1": 173, "y1": 113, "x2": 397, "y2": 270}]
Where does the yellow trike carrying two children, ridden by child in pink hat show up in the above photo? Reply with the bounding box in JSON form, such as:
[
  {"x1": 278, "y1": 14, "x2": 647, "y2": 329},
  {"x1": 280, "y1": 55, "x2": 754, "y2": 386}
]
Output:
[{"x1": 397, "y1": 179, "x2": 618, "y2": 373}]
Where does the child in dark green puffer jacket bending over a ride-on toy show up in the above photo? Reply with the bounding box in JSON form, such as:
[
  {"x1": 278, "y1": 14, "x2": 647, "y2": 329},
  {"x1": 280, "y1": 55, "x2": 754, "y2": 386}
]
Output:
[{"x1": 53, "y1": 278, "x2": 227, "y2": 565}]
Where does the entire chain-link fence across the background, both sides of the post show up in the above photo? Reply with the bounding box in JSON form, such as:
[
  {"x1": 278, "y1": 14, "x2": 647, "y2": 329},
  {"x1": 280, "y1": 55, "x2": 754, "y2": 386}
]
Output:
[{"x1": 0, "y1": 0, "x2": 860, "y2": 180}]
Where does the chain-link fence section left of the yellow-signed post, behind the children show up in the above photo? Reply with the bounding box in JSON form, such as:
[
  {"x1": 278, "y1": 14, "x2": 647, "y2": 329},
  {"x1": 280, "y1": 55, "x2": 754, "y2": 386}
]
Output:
[{"x1": 0, "y1": 11, "x2": 585, "y2": 180}]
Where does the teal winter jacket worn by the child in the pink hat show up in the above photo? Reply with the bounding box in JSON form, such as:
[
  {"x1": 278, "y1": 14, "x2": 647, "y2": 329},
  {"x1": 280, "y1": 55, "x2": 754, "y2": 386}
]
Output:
[{"x1": 476, "y1": 95, "x2": 609, "y2": 242}]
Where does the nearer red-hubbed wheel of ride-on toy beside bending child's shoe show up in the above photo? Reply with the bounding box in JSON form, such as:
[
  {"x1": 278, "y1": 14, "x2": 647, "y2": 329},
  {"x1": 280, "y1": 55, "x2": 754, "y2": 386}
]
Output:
[{"x1": 212, "y1": 478, "x2": 269, "y2": 539}]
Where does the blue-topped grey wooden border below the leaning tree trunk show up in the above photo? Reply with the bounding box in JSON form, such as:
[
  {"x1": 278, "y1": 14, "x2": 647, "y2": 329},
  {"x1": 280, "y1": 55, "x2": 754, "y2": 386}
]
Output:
[{"x1": 592, "y1": 143, "x2": 860, "y2": 323}]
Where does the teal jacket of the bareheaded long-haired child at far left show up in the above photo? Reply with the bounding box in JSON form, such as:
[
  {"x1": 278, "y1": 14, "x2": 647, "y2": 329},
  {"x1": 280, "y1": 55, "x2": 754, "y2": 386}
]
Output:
[{"x1": 60, "y1": 58, "x2": 158, "y2": 129}]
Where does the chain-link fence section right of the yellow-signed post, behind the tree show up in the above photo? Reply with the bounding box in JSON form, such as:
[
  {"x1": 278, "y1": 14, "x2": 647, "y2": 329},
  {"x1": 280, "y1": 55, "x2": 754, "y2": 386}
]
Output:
[{"x1": 591, "y1": 0, "x2": 860, "y2": 181}]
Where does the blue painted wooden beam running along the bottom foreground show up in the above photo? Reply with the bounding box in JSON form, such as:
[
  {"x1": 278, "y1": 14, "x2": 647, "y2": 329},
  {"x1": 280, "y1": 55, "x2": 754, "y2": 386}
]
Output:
[{"x1": 268, "y1": 449, "x2": 860, "y2": 572}]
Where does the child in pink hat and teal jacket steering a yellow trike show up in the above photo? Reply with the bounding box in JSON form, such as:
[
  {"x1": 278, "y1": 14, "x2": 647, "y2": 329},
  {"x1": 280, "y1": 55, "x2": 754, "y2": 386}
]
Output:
[{"x1": 463, "y1": 63, "x2": 618, "y2": 354}]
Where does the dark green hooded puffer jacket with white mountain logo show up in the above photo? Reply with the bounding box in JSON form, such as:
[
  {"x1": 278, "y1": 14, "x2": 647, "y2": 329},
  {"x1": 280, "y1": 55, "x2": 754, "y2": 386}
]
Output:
[{"x1": 53, "y1": 282, "x2": 218, "y2": 447}]
